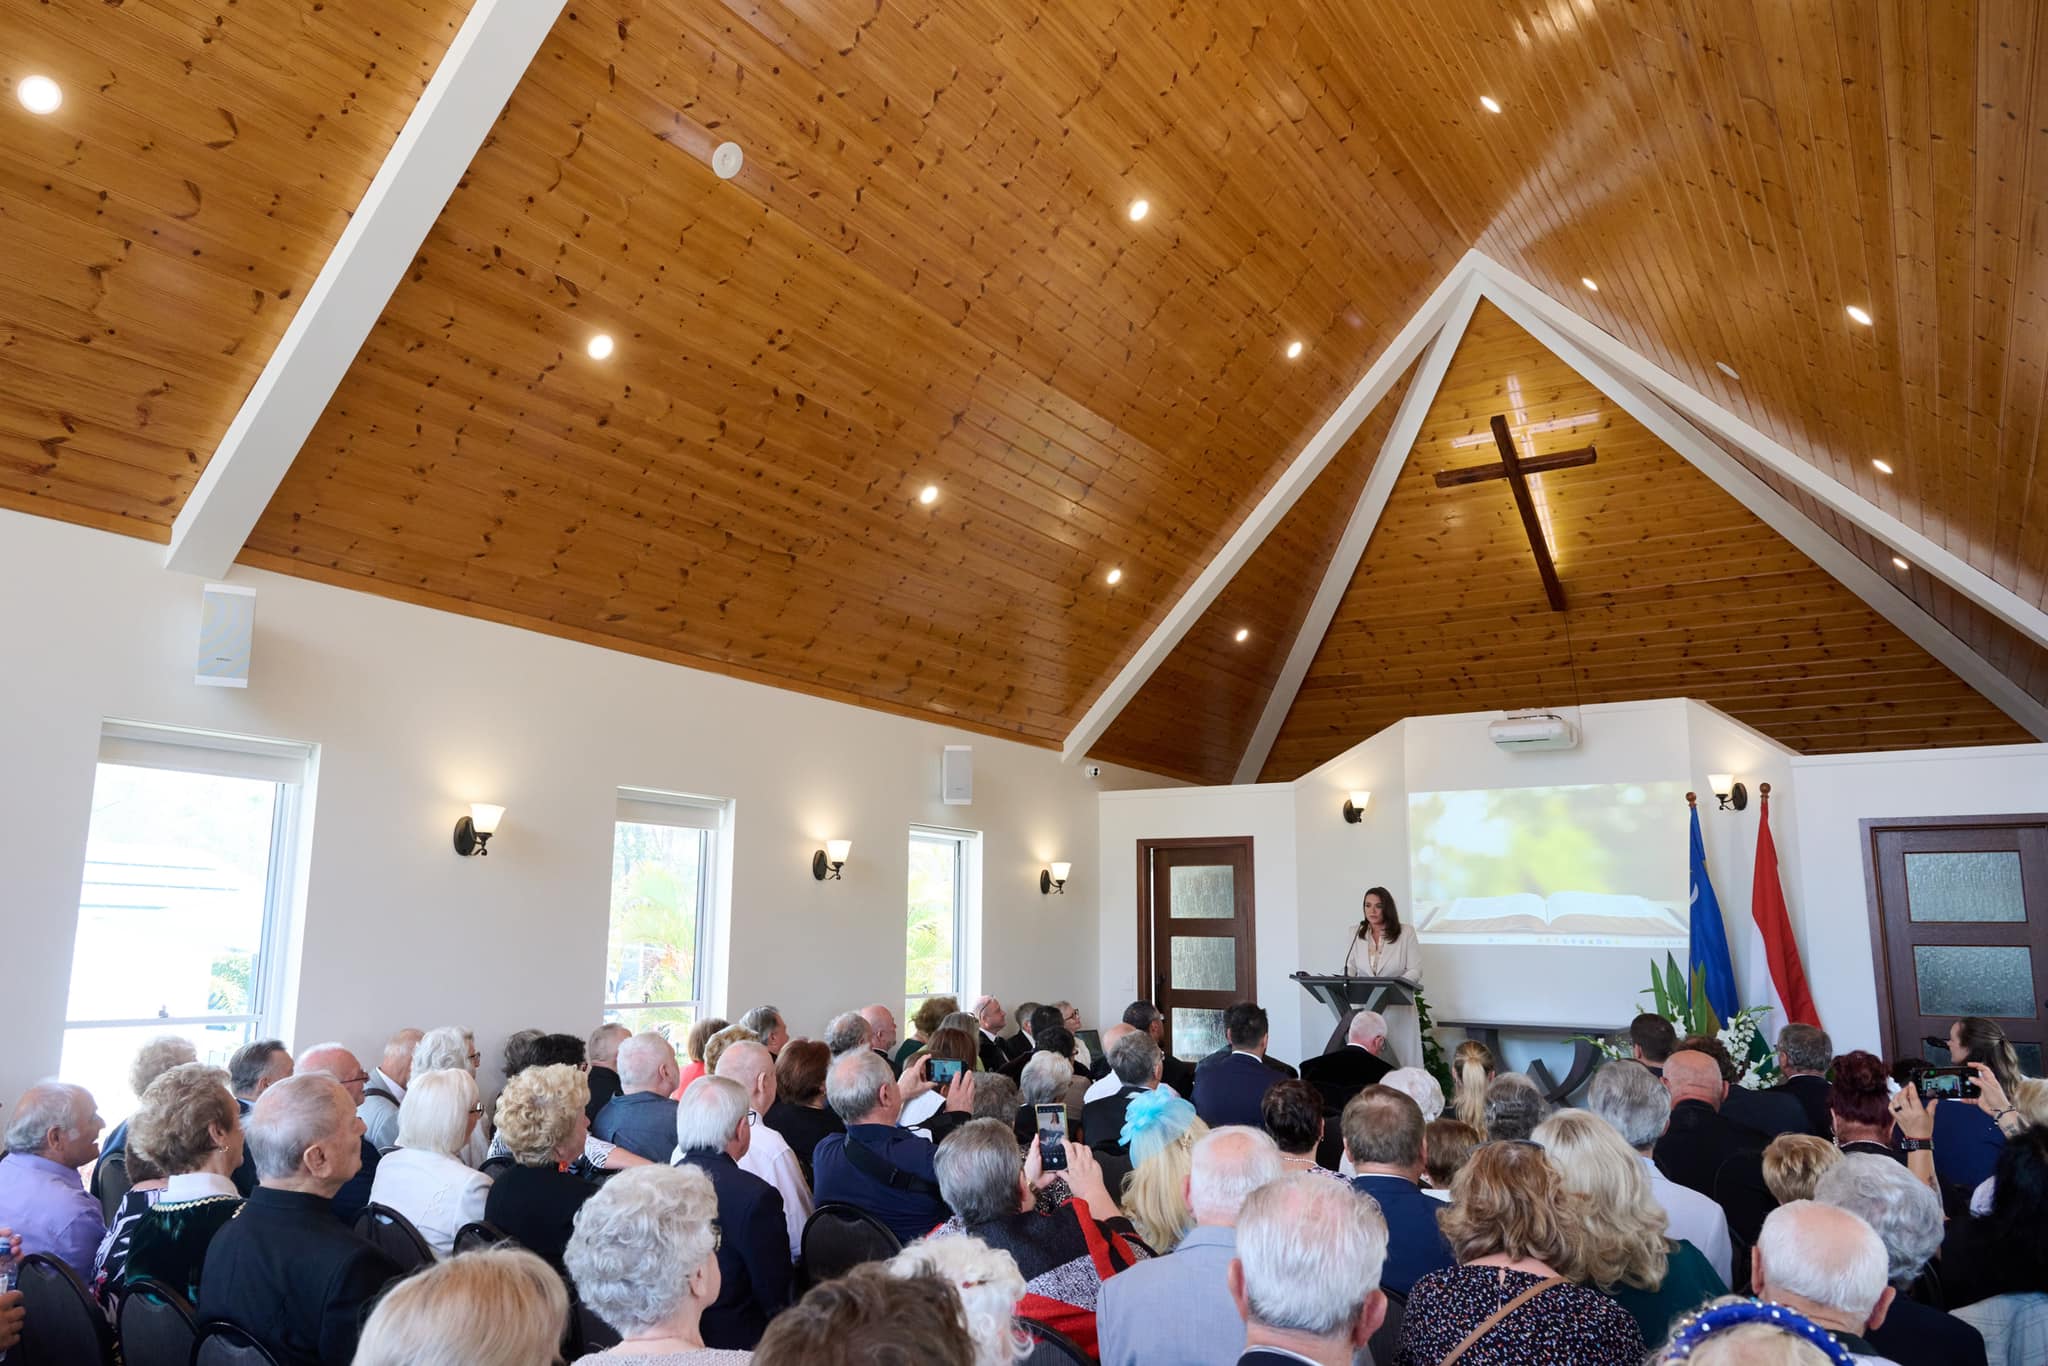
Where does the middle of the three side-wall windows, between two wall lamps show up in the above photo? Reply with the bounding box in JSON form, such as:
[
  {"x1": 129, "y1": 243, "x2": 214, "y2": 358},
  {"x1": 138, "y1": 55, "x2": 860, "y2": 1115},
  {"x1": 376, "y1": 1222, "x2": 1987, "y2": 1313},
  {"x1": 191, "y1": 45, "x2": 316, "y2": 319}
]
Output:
[{"x1": 604, "y1": 788, "x2": 727, "y2": 1049}]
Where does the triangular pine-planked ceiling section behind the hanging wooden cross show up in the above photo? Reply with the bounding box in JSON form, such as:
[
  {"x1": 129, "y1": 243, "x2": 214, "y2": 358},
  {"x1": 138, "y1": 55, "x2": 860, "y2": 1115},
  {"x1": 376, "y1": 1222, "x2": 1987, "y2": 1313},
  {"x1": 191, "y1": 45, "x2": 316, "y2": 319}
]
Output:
[{"x1": 1262, "y1": 303, "x2": 2030, "y2": 780}]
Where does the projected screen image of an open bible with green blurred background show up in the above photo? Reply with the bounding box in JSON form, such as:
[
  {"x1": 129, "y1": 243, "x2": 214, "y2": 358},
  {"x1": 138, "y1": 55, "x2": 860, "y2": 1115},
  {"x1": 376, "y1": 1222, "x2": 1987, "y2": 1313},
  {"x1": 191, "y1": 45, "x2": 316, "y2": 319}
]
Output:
[{"x1": 1409, "y1": 782, "x2": 1690, "y2": 948}]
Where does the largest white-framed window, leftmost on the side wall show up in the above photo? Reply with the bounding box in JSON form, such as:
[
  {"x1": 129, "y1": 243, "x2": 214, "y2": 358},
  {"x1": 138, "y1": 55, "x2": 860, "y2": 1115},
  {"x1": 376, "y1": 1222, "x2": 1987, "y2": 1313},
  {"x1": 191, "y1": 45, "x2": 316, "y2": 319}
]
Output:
[{"x1": 59, "y1": 721, "x2": 311, "y2": 1124}]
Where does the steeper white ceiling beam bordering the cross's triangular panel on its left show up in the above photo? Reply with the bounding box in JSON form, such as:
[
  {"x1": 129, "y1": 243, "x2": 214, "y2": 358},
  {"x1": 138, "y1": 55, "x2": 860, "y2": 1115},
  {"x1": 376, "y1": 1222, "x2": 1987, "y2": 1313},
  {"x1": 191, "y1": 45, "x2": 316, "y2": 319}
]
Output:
[{"x1": 1235, "y1": 278, "x2": 1479, "y2": 782}]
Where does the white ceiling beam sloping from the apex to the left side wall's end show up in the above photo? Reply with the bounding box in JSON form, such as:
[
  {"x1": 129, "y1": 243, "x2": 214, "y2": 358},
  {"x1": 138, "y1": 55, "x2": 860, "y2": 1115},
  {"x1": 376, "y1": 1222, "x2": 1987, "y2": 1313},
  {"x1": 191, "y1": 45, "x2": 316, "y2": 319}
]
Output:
[{"x1": 1061, "y1": 260, "x2": 1468, "y2": 764}]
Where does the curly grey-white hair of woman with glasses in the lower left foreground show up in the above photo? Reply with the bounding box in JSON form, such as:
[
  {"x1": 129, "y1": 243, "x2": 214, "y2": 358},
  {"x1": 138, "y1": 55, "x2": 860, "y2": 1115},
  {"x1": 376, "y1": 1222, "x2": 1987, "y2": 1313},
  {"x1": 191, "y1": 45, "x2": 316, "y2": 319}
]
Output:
[{"x1": 561, "y1": 1163, "x2": 719, "y2": 1333}]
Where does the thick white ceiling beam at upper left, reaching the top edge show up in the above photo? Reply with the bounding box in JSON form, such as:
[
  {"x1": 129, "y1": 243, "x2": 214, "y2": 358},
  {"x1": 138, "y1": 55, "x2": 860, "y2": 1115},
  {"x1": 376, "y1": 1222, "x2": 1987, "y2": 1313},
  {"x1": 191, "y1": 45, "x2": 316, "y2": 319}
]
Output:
[{"x1": 166, "y1": 0, "x2": 565, "y2": 578}]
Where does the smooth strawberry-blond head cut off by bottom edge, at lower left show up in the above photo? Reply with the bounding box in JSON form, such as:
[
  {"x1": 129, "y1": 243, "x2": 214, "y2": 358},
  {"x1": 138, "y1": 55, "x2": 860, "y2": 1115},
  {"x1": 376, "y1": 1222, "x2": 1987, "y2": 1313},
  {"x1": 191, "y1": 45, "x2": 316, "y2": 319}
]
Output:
[{"x1": 354, "y1": 1245, "x2": 561, "y2": 1366}]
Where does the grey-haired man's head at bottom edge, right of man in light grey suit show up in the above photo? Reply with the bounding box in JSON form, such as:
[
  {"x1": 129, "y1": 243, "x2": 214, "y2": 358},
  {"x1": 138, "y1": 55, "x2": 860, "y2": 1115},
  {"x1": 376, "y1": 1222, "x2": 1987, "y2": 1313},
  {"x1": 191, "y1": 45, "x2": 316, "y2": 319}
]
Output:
[{"x1": 1229, "y1": 1176, "x2": 1386, "y2": 1366}]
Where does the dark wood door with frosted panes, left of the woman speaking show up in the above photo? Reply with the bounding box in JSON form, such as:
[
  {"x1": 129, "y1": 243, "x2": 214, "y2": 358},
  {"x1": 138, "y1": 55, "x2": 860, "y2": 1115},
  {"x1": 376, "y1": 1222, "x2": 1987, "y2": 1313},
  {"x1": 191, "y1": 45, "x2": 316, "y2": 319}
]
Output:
[{"x1": 1139, "y1": 836, "x2": 1257, "y2": 1063}]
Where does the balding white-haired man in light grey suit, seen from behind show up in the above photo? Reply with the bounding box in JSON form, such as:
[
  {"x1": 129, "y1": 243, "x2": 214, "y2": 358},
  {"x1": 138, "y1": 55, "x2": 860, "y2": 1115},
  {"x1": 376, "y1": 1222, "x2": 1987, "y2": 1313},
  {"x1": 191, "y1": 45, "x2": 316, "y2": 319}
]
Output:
[{"x1": 1096, "y1": 1124, "x2": 1286, "y2": 1366}]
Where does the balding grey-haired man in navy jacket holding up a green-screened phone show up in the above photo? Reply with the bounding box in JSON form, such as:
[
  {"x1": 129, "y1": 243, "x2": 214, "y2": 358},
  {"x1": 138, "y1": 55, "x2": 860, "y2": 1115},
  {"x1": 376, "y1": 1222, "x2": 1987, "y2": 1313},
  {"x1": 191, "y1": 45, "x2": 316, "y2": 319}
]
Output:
[{"x1": 811, "y1": 1051, "x2": 973, "y2": 1243}]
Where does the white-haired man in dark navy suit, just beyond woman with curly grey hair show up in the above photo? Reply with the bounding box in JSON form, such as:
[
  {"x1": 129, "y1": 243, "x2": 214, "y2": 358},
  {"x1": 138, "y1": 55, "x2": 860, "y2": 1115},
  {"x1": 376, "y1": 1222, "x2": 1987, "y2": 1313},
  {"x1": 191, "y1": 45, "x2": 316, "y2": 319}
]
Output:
[{"x1": 676, "y1": 1081, "x2": 794, "y2": 1352}]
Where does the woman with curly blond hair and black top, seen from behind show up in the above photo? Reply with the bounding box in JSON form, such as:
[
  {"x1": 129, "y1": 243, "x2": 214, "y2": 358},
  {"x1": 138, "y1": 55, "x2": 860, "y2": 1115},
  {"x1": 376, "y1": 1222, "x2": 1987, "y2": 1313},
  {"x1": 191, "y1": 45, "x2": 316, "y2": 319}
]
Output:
[{"x1": 483, "y1": 1064, "x2": 598, "y2": 1272}]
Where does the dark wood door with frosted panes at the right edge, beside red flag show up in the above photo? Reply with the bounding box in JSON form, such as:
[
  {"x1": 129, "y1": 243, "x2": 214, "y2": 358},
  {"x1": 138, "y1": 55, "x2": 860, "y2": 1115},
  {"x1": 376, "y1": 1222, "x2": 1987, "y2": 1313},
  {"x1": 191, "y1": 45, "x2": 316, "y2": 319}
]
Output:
[{"x1": 1864, "y1": 815, "x2": 2048, "y2": 1077}]
